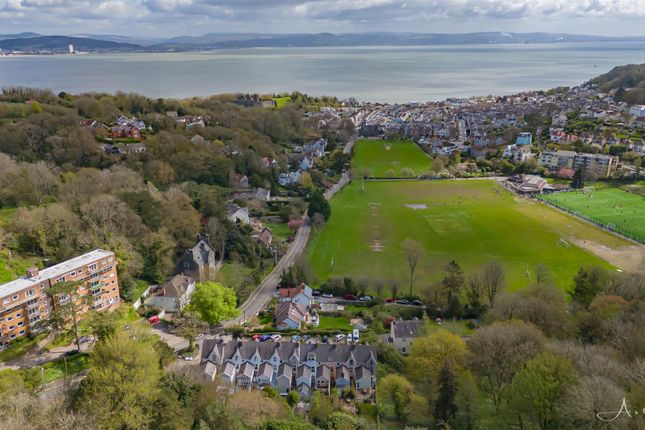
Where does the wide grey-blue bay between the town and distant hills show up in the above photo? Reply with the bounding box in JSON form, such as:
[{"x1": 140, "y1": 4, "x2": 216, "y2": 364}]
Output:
[{"x1": 0, "y1": 42, "x2": 645, "y2": 103}]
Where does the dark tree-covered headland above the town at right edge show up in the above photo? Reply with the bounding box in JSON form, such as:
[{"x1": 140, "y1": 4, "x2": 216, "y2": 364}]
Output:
[{"x1": 590, "y1": 64, "x2": 645, "y2": 104}]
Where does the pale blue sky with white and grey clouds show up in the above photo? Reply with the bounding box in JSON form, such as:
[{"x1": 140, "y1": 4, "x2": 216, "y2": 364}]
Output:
[{"x1": 0, "y1": 0, "x2": 645, "y2": 38}]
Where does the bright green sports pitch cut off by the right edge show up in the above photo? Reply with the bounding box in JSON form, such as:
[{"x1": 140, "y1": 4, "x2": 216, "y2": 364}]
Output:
[{"x1": 542, "y1": 188, "x2": 645, "y2": 243}]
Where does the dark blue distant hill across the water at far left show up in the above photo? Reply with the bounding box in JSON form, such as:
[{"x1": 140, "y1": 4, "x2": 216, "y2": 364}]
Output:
[{"x1": 0, "y1": 36, "x2": 144, "y2": 52}]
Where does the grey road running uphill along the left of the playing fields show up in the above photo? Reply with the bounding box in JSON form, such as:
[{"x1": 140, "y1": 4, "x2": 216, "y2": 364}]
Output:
[{"x1": 222, "y1": 140, "x2": 355, "y2": 327}]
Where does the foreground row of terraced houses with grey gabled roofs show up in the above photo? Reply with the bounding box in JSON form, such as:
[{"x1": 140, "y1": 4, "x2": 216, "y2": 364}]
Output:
[{"x1": 201, "y1": 339, "x2": 376, "y2": 401}]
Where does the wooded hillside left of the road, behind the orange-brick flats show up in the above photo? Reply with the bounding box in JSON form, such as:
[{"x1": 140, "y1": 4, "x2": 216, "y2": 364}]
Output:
[{"x1": 0, "y1": 88, "x2": 348, "y2": 300}]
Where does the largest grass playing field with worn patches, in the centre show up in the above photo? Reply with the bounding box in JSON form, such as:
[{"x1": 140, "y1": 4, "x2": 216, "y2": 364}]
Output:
[{"x1": 308, "y1": 180, "x2": 630, "y2": 293}]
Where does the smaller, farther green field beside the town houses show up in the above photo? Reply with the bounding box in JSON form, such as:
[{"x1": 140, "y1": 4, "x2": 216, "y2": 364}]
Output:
[{"x1": 352, "y1": 139, "x2": 432, "y2": 178}]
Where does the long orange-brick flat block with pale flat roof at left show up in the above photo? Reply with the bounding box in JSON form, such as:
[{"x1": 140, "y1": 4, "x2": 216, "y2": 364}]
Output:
[{"x1": 0, "y1": 249, "x2": 119, "y2": 348}]
